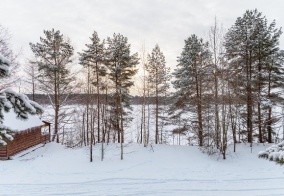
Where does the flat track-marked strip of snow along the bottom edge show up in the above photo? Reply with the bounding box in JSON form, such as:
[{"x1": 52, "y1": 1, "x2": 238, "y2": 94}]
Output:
[{"x1": 1, "y1": 177, "x2": 284, "y2": 196}]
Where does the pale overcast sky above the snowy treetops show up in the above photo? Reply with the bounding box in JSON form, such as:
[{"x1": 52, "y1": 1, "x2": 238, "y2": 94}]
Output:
[{"x1": 0, "y1": 0, "x2": 284, "y2": 92}]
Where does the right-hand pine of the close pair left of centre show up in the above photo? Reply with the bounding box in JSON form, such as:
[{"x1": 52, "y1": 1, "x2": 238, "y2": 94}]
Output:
[{"x1": 106, "y1": 34, "x2": 139, "y2": 159}]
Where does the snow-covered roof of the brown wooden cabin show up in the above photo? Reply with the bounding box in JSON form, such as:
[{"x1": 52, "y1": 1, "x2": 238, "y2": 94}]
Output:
[{"x1": 3, "y1": 110, "x2": 44, "y2": 131}]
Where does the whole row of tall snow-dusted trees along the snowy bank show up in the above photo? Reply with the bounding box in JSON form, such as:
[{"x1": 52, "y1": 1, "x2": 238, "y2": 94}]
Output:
[{"x1": 0, "y1": 10, "x2": 284, "y2": 161}]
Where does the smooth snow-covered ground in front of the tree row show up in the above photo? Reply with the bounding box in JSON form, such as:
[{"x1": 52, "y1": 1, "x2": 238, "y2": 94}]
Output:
[{"x1": 0, "y1": 143, "x2": 284, "y2": 196}]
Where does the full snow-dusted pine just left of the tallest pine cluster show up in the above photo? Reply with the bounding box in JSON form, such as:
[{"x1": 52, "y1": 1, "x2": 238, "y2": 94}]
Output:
[{"x1": 173, "y1": 35, "x2": 211, "y2": 146}]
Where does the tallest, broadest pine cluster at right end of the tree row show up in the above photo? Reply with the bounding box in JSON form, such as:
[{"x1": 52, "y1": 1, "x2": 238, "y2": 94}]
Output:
[{"x1": 225, "y1": 10, "x2": 282, "y2": 143}]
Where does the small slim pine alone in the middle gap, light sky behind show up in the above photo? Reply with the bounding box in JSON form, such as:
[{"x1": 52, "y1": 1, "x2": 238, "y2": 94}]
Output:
[{"x1": 145, "y1": 44, "x2": 170, "y2": 144}]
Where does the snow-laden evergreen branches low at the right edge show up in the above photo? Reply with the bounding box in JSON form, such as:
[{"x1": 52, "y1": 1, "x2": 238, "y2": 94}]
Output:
[{"x1": 258, "y1": 141, "x2": 284, "y2": 164}]
